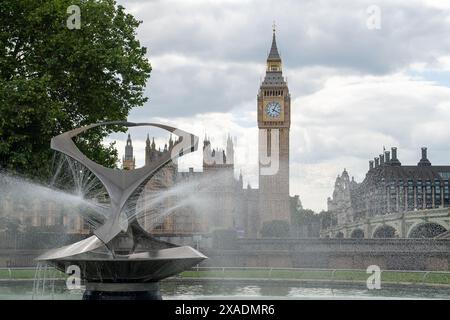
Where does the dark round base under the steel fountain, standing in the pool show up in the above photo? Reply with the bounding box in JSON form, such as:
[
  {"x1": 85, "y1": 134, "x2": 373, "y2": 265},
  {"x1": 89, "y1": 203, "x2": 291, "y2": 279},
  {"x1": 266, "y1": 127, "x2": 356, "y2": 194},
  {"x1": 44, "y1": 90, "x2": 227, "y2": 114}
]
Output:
[{"x1": 83, "y1": 282, "x2": 162, "y2": 300}]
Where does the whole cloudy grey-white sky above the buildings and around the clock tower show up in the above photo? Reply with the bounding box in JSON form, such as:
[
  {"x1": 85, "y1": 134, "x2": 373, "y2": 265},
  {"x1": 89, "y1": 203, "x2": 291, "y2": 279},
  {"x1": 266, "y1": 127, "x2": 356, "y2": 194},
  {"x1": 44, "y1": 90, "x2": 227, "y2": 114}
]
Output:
[{"x1": 111, "y1": 0, "x2": 450, "y2": 210}]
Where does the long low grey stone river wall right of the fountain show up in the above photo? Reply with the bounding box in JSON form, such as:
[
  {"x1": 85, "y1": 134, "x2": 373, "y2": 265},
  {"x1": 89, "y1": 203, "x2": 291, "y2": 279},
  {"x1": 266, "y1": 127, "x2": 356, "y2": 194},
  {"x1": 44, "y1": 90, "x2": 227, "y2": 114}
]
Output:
[{"x1": 203, "y1": 239, "x2": 450, "y2": 270}]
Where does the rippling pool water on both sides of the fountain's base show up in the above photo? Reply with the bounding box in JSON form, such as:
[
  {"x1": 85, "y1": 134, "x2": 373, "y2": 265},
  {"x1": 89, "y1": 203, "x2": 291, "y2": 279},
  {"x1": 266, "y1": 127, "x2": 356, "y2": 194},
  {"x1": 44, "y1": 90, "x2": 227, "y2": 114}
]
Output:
[{"x1": 0, "y1": 279, "x2": 450, "y2": 300}]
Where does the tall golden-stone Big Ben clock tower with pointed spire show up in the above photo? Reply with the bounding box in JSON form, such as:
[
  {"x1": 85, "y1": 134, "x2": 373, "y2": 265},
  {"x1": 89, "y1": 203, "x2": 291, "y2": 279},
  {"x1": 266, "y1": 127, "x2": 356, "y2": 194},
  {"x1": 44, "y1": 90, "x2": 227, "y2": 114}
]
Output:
[{"x1": 257, "y1": 27, "x2": 291, "y2": 230}]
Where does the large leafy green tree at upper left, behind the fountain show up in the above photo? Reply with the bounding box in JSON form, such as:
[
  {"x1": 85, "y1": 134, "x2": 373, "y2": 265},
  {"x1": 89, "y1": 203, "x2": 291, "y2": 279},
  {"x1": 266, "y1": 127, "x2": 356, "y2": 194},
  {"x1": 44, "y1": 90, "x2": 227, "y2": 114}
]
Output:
[{"x1": 0, "y1": 0, "x2": 151, "y2": 178}]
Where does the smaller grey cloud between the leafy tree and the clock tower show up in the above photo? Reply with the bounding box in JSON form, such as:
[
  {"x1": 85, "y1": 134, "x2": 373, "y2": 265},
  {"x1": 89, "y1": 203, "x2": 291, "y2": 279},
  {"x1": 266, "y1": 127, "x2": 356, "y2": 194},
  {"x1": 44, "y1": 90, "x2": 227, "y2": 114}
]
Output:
[{"x1": 128, "y1": 60, "x2": 258, "y2": 118}]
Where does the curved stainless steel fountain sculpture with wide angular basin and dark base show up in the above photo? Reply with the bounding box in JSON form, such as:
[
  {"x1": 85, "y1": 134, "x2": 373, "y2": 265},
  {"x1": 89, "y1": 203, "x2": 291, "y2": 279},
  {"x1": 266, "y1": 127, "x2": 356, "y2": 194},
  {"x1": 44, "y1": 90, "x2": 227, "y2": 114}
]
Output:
[{"x1": 37, "y1": 121, "x2": 206, "y2": 300}]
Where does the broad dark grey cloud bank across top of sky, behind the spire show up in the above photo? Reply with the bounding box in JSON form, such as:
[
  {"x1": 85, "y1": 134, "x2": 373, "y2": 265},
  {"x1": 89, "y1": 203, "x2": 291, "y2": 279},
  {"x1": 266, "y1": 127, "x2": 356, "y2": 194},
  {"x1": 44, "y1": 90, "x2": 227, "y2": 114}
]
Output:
[{"x1": 121, "y1": 0, "x2": 450, "y2": 74}]
